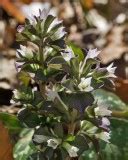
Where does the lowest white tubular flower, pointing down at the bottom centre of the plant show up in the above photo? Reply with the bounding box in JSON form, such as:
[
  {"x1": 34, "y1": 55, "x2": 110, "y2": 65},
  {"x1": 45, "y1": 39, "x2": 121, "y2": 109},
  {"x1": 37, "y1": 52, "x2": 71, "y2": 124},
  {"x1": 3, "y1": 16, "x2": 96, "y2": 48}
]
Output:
[{"x1": 63, "y1": 142, "x2": 79, "y2": 157}]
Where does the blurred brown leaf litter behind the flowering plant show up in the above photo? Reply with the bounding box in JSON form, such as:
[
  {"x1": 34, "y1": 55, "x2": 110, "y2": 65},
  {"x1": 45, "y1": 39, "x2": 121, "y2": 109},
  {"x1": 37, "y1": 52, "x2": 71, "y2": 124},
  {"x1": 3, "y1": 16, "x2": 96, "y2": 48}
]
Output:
[{"x1": 0, "y1": 0, "x2": 128, "y2": 160}]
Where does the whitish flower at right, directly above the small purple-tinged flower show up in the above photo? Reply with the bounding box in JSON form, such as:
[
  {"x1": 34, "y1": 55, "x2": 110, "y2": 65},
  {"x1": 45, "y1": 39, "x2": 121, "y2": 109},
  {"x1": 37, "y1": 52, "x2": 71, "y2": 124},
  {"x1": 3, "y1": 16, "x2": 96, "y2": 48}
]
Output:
[{"x1": 94, "y1": 101, "x2": 112, "y2": 116}]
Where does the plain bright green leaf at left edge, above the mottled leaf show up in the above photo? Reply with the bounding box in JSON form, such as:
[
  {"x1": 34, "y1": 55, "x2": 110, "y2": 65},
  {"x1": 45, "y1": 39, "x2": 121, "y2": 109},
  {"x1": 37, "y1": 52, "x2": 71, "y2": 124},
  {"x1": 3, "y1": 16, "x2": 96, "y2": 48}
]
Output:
[{"x1": 0, "y1": 112, "x2": 22, "y2": 132}]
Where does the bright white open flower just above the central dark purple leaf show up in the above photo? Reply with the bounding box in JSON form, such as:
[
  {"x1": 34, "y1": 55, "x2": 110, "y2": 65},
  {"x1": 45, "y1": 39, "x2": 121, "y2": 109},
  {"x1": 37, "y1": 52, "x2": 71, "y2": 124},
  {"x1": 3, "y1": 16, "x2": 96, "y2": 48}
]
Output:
[{"x1": 78, "y1": 77, "x2": 93, "y2": 92}]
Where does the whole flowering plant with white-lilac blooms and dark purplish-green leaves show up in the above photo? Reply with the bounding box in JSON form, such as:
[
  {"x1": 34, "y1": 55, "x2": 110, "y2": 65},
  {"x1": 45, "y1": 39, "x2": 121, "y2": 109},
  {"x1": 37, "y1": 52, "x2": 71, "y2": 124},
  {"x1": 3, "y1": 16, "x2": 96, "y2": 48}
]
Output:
[{"x1": 13, "y1": 10, "x2": 115, "y2": 160}]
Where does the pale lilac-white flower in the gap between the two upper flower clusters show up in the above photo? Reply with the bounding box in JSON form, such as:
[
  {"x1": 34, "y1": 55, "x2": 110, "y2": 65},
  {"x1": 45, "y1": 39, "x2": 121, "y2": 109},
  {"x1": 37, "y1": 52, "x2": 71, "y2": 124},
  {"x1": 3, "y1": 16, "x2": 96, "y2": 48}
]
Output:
[{"x1": 61, "y1": 47, "x2": 74, "y2": 62}]
